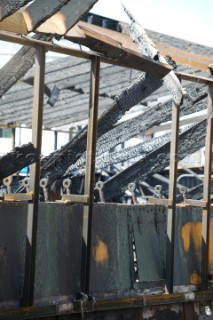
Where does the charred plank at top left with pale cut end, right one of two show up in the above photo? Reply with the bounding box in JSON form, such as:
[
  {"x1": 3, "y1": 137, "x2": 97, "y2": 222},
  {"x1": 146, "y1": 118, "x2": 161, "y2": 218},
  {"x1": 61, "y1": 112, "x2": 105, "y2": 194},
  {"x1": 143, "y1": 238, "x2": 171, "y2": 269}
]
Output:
[{"x1": 37, "y1": 0, "x2": 98, "y2": 35}]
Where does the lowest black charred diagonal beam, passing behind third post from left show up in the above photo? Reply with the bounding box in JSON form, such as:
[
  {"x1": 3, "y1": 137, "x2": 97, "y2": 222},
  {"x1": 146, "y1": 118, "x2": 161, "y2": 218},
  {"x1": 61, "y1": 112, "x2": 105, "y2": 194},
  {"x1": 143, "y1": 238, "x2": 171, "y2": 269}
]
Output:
[{"x1": 103, "y1": 120, "x2": 206, "y2": 201}]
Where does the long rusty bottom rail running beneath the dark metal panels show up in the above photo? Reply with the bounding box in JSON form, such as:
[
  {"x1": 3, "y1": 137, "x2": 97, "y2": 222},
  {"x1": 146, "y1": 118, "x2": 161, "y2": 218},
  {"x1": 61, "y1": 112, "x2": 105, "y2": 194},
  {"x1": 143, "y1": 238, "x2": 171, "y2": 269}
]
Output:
[{"x1": 0, "y1": 290, "x2": 213, "y2": 320}]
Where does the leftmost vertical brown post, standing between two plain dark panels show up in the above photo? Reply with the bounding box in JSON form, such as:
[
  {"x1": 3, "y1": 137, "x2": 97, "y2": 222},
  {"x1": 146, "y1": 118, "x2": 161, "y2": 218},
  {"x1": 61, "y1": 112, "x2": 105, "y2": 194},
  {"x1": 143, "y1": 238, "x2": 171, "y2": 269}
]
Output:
[{"x1": 23, "y1": 45, "x2": 45, "y2": 306}]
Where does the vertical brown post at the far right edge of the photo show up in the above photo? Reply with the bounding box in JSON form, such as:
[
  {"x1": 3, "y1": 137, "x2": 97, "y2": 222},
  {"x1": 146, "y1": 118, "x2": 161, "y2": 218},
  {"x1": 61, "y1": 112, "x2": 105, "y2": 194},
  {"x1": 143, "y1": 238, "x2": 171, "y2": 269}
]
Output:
[{"x1": 201, "y1": 84, "x2": 213, "y2": 290}]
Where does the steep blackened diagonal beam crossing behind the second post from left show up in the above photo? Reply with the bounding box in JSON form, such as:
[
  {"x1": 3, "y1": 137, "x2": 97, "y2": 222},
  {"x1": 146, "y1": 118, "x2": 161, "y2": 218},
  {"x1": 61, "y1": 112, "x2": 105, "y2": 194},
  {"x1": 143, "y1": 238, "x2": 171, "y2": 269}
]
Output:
[{"x1": 41, "y1": 73, "x2": 162, "y2": 185}]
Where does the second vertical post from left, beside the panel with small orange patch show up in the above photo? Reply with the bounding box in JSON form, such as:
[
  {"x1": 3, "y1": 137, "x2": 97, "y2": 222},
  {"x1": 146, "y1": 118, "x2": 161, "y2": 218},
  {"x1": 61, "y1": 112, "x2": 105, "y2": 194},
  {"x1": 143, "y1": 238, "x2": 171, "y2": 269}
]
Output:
[{"x1": 81, "y1": 57, "x2": 100, "y2": 293}]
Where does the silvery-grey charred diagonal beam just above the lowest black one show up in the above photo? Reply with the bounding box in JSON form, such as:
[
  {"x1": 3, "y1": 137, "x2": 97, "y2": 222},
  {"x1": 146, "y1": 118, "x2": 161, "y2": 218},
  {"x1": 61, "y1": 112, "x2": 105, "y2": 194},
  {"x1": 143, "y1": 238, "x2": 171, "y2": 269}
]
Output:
[{"x1": 67, "y1": 85, "x2": 207, "y2": 173}]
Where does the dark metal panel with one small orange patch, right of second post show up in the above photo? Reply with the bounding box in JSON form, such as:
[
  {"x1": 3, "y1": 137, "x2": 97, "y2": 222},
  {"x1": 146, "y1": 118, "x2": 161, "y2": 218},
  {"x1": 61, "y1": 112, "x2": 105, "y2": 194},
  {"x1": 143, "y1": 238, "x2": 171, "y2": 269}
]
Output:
[{"x1": 90, "y1": 204, "x2": 131, "y2": 294}]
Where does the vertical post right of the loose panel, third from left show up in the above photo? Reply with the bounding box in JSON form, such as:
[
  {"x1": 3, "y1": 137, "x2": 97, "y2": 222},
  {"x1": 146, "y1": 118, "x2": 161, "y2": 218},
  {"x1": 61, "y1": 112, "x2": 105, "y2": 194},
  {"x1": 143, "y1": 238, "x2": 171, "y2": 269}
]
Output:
[{"x1": 166, "y1": 102, "x2": 180, "y2": 293}]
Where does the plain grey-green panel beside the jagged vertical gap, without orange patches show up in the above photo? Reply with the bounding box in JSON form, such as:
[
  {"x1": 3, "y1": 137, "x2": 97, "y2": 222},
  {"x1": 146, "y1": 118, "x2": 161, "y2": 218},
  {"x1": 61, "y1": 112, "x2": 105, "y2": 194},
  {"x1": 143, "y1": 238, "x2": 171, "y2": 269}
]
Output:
[{"x1": 131, "y1": 205, "x2": 166, "y2": 282}]
